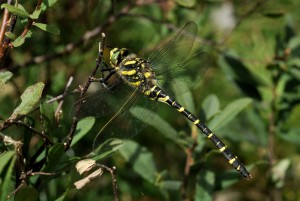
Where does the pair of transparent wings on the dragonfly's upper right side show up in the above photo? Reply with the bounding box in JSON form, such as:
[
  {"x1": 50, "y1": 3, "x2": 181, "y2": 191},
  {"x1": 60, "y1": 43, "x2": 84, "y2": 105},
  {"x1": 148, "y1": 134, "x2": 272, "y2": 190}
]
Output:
[{"x1": 148, "y1": 22, "x2": 209, "y2": 96}]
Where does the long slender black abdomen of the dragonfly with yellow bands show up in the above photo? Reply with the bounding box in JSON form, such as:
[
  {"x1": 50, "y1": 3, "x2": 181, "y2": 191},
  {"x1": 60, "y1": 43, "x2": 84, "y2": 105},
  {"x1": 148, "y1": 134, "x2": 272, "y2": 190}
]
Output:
[{"x1": 145, "y1": 86, "x2": 251, "y2": 179}]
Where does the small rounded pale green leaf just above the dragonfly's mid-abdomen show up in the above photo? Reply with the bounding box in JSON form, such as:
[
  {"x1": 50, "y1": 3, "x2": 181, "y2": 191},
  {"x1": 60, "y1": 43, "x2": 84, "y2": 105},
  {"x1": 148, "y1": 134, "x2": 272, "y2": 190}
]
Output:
[{"x1": 202, "y1": 94, "x2": 220, "y2": 120}]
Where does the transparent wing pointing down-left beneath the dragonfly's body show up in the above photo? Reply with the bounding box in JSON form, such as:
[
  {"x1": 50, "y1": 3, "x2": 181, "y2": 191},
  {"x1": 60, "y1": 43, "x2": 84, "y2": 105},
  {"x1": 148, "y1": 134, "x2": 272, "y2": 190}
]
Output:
[{"x1": 93, "y1": 86, "x2": 157, "y2": 153}]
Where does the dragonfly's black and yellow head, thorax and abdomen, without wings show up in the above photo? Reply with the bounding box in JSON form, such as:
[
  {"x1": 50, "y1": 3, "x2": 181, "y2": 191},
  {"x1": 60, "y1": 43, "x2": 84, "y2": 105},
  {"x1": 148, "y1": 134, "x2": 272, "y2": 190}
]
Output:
[{"x1": 105, "y1": 48, "x2": 251, "y2": 179}]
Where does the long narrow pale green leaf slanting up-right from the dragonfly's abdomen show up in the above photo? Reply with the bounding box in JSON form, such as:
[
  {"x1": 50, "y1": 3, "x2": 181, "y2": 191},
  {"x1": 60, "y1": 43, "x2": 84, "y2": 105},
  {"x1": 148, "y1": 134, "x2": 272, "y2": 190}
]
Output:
[{"x1": 209, "y1": 98, "x2": 252, "y2": 130}]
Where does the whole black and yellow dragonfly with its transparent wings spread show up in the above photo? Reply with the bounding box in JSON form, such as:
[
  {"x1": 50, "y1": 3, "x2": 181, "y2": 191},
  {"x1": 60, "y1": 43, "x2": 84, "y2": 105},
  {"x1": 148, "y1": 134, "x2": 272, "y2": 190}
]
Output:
[{"x1": 82, "y1": 21, "x2": 251, "y2": 179}]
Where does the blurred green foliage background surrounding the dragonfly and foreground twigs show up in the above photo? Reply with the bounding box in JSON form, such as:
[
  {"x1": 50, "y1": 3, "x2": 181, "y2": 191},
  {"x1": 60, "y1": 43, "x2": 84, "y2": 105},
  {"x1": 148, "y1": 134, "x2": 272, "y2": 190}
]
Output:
[{"x1": 0, "y1": 0, "x2": 300, "y2": 201}]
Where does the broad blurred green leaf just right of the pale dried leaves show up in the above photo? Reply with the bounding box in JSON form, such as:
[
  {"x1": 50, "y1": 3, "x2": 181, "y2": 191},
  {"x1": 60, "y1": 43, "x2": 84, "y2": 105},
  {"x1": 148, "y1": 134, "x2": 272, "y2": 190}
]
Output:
[{"x1": 119, "y1": 141, "x2": 157, "y2": 183}]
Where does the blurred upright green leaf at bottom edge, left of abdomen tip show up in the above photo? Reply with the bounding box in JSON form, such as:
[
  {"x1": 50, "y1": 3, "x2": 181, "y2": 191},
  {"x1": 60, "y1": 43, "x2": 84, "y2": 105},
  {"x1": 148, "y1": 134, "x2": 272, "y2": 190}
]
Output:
[{"x1": 195, "y1": 169, "x2": 215, "y2": 201}]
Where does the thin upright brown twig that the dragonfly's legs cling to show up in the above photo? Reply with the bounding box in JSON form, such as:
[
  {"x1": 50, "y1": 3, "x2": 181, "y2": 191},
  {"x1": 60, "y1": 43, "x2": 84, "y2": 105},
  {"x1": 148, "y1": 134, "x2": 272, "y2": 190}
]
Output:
[{"x1": 64, "y1": 33, "x2": 105, "y2": 150}]
